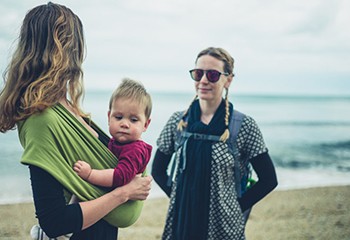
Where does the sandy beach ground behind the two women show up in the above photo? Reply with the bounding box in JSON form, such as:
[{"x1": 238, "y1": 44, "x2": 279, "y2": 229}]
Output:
[{"x1": 0, "y1": 186, "x2": 350, "y2": 240}]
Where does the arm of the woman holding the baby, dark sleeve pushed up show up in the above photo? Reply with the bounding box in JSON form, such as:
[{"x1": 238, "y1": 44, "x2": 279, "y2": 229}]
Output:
[{"x1": 29, "y1": 166, "x2": 152, "y2": 237}]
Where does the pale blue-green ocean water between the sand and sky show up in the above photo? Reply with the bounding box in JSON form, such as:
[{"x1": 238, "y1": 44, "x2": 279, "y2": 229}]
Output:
[{"x1": 0, "y1": 90, "x2": 350, "y2": 204}]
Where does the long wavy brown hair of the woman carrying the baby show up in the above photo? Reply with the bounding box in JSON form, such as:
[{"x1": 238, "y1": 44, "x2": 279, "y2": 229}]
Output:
[{"x1": 0, "y1": 2, "x2": 85, "y2": 132}]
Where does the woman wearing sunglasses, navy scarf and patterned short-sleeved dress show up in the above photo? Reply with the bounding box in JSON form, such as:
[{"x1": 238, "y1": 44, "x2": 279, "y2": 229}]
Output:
[{"x1": 152, "y1": 47, "x2": 277, "y2": 240}]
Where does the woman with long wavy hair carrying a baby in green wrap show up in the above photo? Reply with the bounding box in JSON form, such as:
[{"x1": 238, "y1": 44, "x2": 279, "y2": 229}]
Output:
[{"x1": 0, "y1": 2, "x2": 152, "y2": 240}]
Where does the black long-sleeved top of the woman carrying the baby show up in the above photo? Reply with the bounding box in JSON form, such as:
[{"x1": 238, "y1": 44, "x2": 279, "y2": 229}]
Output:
[{"x1": 29, "y1": 165, "x2": 118, "y2": 240}]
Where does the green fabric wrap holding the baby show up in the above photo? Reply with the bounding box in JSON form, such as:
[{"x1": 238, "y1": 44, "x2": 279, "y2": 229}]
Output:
[{"x1": 18, "y1": 104, "x2": 143, "y2": 227}]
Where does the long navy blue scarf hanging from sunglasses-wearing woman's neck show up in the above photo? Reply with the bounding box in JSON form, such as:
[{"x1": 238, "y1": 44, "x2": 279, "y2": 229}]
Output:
[{"x1": 173, "y1": 100, "x2": 232, "y2": 240}]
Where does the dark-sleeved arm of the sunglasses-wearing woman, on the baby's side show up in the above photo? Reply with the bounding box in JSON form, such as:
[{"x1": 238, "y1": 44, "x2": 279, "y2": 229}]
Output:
[{"x1": 152, "y1": 149, "x2": 171, "y2": 197}]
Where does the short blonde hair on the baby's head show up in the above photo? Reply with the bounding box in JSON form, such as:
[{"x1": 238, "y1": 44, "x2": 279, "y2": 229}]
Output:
[{"x1": 109, "y1": 78, "x2": 152, "y2": 120}]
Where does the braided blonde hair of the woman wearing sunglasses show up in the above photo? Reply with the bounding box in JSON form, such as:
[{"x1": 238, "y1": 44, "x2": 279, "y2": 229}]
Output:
[{"x1": 177, "y1": 47, "x2": 234, "y2": 142}]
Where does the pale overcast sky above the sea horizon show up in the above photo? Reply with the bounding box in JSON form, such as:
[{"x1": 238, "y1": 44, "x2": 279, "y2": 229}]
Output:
[{"x1": 0, "y1": 0, "x2": 350, "y2": 96}]
